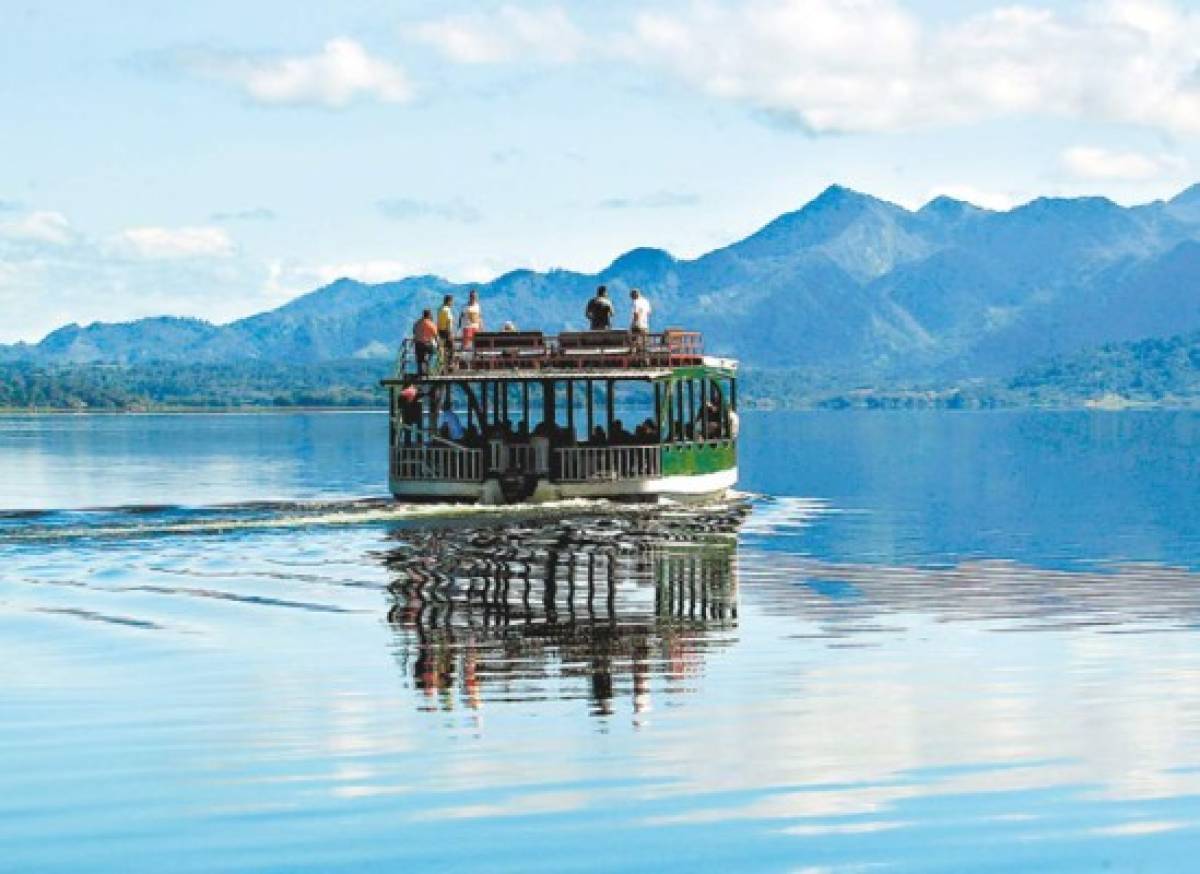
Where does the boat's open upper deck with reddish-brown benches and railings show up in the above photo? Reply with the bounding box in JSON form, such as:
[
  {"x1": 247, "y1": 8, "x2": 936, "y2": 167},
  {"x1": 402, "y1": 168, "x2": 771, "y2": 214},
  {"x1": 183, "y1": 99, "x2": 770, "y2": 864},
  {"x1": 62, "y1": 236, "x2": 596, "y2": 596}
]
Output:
[{"x1": 384, "y1": 328, "x2": 737, "y2": 382}]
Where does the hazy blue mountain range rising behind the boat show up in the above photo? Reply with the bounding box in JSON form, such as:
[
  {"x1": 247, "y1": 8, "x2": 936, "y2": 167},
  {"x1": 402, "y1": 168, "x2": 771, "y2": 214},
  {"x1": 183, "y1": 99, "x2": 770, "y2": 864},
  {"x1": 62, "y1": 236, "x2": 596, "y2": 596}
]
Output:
[{"x1": 7, "y1": 185, "x2": 1200, "y2": 381}]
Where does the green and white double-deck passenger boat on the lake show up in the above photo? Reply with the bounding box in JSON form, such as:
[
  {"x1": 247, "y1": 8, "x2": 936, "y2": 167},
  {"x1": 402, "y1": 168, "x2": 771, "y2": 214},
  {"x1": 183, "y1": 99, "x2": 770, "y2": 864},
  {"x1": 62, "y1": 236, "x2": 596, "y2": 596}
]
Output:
[{"x1": 383, "y1": 330, "x2": 738, "y2": 504}]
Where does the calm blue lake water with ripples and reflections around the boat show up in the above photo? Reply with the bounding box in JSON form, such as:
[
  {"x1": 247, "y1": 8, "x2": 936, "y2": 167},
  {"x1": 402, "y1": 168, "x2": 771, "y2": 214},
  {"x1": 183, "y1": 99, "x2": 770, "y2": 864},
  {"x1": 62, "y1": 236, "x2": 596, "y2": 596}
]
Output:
[{"x1": 0, "y1": 412, "x2": 1200, "y2": 872}]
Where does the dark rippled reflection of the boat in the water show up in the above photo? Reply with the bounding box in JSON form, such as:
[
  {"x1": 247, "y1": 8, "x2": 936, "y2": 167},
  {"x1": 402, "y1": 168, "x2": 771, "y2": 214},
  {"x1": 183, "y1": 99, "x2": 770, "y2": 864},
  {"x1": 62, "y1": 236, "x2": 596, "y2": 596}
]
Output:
[{"x1": 384, "y1": 504, "x2": 745, "y2": 714}]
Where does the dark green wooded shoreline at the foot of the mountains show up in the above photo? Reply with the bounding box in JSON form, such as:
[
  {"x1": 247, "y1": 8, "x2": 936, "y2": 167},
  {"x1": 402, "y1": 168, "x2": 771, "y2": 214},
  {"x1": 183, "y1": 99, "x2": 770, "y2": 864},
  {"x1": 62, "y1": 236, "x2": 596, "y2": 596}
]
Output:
[{"x1": 0, "y1": 333, "x2": 1200, "y2": 409}]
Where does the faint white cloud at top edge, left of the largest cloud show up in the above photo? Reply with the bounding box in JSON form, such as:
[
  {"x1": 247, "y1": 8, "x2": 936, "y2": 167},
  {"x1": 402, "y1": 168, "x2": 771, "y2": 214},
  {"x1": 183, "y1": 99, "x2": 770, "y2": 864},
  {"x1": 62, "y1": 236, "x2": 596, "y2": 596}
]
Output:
[{"x1": 413, "y1": 6, "x2": 586, "y2": 64}]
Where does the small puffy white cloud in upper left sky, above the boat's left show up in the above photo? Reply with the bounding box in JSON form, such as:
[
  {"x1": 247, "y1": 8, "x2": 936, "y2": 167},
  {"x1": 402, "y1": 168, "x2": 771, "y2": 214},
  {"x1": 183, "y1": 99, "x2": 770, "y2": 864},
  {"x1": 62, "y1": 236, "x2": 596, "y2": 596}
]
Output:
[{"x1": 186, "y1": 37, "x2": 413, "y2": 109}]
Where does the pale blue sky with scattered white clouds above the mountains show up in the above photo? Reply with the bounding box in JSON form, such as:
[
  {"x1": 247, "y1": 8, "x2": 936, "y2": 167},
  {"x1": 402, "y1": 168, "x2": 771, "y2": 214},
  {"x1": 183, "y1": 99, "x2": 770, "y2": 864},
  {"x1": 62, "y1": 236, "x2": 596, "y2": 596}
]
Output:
[{"x1": 0, "y1": 0, "x2": 1200, "y2": 342}]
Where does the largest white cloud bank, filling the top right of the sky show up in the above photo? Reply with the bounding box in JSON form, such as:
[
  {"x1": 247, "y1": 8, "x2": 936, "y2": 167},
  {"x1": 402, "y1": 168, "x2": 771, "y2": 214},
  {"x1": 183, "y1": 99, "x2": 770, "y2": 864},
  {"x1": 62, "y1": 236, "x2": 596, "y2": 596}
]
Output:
[{"x1": 626, "y1": 0, "x2": 1200, "y2": 133}]
